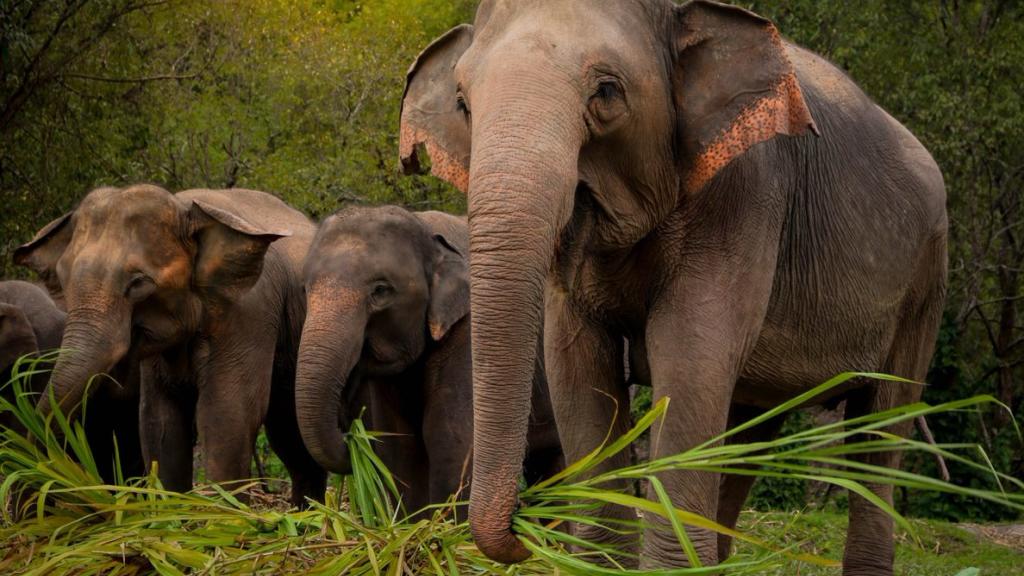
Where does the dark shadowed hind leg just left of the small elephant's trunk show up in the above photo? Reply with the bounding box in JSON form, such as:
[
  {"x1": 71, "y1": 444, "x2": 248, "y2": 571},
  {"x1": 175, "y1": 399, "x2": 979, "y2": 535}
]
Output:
[{"x1": 265, "y1": 374, "x2": 327, "y2": 507}]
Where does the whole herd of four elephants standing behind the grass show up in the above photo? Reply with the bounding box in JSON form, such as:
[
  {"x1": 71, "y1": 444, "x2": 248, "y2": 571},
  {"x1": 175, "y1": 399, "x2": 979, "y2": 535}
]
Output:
[{"x1": 0, "y1": 0, "x2": 948, "y2": 576}]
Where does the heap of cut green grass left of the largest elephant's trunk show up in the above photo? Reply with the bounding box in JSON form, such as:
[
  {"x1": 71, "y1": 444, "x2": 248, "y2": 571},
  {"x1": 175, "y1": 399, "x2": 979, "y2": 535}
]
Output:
[{"x1": 0, "y1": 361, "x2": 547, "y2": 575}]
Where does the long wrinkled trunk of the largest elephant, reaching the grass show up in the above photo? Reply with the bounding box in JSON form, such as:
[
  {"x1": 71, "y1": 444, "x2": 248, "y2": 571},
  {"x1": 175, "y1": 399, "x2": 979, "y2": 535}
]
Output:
[{"x1": 469, "y1": 75, "x2": 586, "y2": 563}]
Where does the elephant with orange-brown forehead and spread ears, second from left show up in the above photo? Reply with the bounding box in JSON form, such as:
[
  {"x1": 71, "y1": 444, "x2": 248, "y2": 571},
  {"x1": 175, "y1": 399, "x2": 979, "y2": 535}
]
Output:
[{"x1": 14, "y1": 184, "x2": 327, "y2": 505}]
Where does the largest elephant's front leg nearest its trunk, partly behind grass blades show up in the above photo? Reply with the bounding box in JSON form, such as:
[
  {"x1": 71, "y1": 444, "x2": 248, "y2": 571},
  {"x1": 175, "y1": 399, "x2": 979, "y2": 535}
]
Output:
[{"x1": 544, "y1": 290, "x2": 639, "y2": 567}]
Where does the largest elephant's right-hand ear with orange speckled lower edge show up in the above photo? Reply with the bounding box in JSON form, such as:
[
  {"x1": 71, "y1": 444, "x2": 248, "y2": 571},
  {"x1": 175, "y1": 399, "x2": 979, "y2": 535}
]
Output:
[{"x1": 673, "y1": 0, "x2": 817, "y2": 194}]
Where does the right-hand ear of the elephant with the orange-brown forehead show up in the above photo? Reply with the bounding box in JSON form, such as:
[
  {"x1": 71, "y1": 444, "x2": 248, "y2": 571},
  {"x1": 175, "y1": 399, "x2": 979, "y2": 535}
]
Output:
[{"x1": 188, "y1": 200, "x2": 292, "y2": 311}]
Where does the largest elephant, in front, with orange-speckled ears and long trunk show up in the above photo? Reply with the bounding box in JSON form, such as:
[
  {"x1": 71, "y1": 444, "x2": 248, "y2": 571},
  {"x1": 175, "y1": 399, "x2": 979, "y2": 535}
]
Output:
[{"x1": 400, "y1": 0, "x2": 947, "y2": 576}]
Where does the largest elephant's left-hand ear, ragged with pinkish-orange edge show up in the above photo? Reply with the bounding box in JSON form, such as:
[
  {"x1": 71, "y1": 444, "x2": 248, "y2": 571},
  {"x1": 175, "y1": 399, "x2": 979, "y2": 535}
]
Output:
[{"x1": 398, "y1": 25, "x2": 473, "y2": 193}]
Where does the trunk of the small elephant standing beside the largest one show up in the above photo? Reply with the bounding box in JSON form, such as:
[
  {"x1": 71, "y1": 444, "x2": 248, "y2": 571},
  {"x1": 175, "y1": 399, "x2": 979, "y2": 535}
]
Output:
[{"x1": 295, "y1": 292, "x2": 366, "y2": 474}]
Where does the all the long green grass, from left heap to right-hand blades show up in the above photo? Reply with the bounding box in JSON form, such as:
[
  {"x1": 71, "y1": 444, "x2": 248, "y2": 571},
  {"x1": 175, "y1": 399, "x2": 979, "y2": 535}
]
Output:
[{"x1": 0, "y1": 360, "x2": 1024, "y2": 575}]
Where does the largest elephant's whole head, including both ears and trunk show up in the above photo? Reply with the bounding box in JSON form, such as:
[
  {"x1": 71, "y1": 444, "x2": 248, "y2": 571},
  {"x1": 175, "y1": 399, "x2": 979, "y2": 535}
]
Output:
[{"x1": 400, "y1": 0, "x2": 814, "y2": 562}]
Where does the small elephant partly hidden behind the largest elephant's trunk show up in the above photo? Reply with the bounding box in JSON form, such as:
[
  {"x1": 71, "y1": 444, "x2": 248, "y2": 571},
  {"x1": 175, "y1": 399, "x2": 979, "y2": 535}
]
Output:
[{"x1": 296, "y1": 207, "x2": 562, "y2": 513}]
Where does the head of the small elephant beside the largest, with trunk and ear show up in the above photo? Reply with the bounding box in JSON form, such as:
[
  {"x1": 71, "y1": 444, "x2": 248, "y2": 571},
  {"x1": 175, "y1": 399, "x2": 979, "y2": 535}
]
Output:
[{"x1": 295, "y1": 207, "x2": 469, "y2": 474}]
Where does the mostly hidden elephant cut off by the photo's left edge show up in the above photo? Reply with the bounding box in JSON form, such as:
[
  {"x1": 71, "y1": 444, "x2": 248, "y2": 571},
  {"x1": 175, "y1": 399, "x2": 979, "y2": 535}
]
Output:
[{"x1": 0, "y1": 281, "x2": 143, "y2": 482}]
